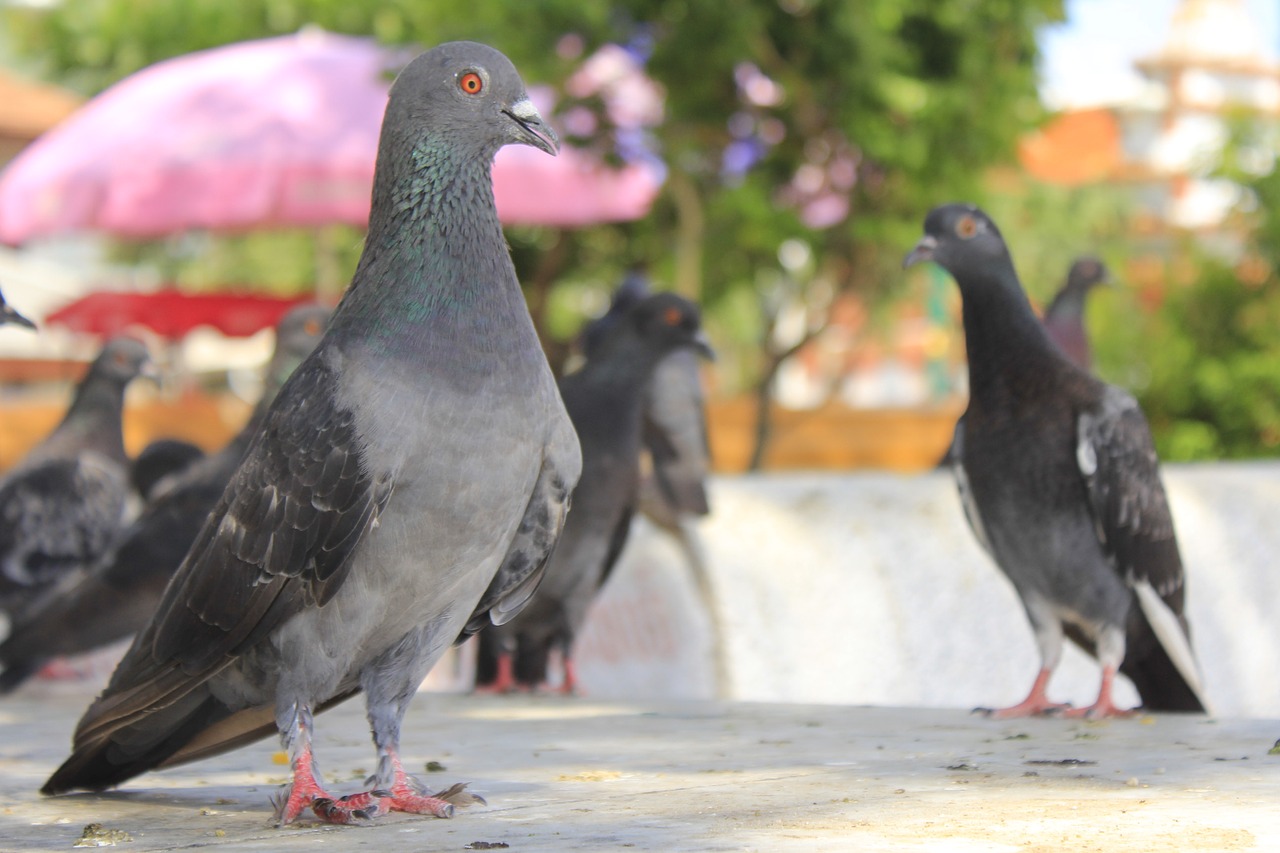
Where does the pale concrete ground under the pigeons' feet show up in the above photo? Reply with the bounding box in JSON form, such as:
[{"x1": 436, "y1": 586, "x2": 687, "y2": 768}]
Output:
[{"x1": 0, "y1": 684, "x2": 1280, "y2": 853}]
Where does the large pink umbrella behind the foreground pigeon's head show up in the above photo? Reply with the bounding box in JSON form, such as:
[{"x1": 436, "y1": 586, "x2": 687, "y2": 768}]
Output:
[{"x1": 0, "y1": 31, "x2": 660, "y2": 245}]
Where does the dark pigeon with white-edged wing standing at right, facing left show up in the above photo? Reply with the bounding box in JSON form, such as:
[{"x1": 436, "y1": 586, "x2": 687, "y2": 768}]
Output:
[{"x1": 905, "y1": 204, "x2": 1207, "y2": 719}]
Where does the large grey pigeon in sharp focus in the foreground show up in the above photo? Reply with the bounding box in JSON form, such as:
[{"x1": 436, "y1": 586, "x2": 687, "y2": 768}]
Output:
[{"x1": 42, "y1": 42, "x2": 581, "y2": 824}]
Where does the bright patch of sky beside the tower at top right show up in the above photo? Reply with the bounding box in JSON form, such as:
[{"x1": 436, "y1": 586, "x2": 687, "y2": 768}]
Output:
[{"x1": 1041, "y1": 0, "x2": 1280, "y2": 108}]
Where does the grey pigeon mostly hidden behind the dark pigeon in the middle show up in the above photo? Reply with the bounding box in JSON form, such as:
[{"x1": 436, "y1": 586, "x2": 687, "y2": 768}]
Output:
[{"x1": 581, "y1": 272, "x2": 710, "y2": 527}]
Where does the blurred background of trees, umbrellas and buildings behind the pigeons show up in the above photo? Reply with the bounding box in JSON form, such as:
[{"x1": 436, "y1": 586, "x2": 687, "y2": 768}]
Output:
[{"x1": 0, "y1": 0, "x2": 1280, "y2": 471}]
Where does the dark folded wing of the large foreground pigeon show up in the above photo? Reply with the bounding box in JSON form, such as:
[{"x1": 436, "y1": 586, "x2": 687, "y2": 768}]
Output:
[{"x1": 69, "y1": 359, "x2": 393, "y2": 742}]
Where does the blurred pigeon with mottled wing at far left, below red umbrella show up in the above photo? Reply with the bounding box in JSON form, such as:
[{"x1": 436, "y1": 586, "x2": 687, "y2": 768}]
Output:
[{"x1": 0, "y1": 337, "x2": 155, "y2": 624}]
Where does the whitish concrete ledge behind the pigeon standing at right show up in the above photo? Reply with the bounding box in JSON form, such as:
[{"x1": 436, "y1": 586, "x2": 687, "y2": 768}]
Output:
[{"x1": 568, "y1": 462, "x2": 1280, "y2": 712}]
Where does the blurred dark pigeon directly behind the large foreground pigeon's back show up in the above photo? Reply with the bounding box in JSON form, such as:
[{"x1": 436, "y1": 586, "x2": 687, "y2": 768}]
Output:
[{"x1": 0, "y1": 304, "x2": 329, "y2": 694}]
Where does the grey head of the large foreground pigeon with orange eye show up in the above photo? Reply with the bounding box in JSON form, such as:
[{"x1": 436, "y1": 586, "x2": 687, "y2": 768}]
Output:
[{"x1": 383, "y1": 41, "x2": 559, "y2": 159}]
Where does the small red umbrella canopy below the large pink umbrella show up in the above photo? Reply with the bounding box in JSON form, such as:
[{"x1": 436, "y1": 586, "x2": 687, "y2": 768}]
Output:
[{"x1": 45, "y1": 289, "x2": 307, "y2": 341}]
